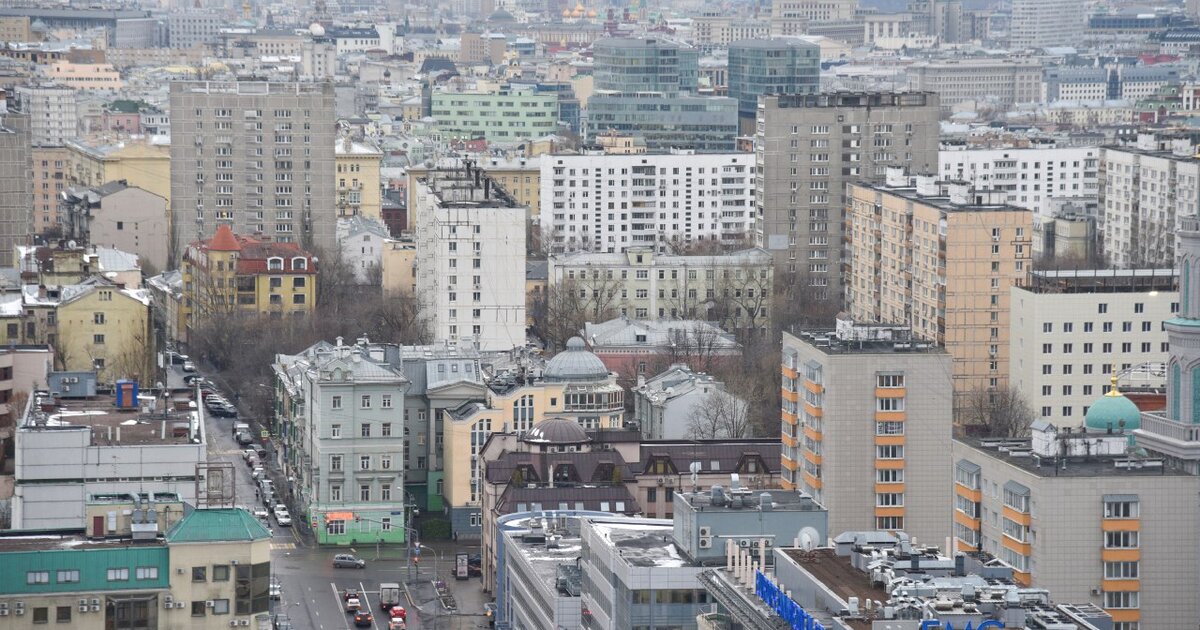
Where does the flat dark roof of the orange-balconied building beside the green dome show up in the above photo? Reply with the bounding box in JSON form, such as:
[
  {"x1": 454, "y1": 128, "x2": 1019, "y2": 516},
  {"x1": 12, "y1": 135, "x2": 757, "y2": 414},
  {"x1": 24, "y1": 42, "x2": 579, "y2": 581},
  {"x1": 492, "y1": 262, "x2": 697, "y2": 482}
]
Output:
[{"x1": 955, "y1": 433, "x2": 1190, "y2": 478}]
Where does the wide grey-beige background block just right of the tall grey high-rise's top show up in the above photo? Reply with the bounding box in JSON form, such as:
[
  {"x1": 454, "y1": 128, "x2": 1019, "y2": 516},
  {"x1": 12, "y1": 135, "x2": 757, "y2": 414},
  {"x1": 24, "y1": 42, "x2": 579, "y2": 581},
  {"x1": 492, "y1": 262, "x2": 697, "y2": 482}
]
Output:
[{"x1": 907, "y1": 59, "x2": 1042, "y2": 114}]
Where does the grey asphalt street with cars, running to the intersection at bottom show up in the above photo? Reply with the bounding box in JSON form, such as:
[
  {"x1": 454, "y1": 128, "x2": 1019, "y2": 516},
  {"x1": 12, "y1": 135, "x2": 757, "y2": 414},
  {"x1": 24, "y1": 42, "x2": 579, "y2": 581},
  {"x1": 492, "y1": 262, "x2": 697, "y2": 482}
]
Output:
[{"x1": 196, "y1": 368, "x2": 491, "y2": 630}]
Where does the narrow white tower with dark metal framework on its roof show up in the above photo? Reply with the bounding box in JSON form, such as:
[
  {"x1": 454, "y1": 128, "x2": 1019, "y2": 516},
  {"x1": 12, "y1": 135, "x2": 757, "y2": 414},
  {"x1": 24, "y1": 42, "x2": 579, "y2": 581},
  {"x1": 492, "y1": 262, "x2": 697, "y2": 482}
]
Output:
[{"x1": 413, "y1": 163, "x2": 526, "y2": 352}]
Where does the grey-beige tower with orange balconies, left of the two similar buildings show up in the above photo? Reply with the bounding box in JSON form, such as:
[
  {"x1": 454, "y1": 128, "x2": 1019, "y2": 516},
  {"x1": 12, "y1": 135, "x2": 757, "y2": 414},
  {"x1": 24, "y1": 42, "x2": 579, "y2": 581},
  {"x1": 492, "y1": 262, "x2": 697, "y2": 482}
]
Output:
[{"x1": 781, "y1": 319, "x2": 953, "y2": 542}]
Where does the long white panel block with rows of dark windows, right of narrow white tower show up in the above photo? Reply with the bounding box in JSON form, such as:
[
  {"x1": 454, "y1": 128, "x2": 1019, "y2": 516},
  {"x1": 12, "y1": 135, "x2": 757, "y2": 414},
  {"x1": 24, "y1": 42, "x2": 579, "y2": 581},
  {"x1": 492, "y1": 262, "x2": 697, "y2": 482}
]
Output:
[{"x1": 540, "y1": 151, "x2": 754, "y2": 252}]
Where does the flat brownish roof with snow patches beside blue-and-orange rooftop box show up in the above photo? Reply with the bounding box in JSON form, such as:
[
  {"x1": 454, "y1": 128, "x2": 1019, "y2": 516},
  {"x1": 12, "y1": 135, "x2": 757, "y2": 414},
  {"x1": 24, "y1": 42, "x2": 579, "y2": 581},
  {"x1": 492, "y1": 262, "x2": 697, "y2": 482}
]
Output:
[{"x1": 20, "y1": 392, "x2": 199, "y2": 446}]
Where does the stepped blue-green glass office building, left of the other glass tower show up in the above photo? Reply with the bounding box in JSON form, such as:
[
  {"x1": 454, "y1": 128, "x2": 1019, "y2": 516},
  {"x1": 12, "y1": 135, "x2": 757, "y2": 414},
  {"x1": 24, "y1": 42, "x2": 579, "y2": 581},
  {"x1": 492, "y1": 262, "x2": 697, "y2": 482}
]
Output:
[{"x1": 588, "y1": 37, "x2": 738, "y2": 152}]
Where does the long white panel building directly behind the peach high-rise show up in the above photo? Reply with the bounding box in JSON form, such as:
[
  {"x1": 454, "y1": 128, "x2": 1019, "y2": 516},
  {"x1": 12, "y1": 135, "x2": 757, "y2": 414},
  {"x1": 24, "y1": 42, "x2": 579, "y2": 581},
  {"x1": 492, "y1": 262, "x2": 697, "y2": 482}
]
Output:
[{"x1": 937, "y1": 144, "x2": 1100, "y2": 221}]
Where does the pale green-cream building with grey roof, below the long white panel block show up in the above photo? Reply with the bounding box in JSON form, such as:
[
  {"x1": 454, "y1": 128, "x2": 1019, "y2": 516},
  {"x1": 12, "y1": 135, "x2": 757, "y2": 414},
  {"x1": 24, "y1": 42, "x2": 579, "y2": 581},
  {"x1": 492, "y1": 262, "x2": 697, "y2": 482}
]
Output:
[{"x1": 547, "y1": 247, "x2": 774, "y2": 334}]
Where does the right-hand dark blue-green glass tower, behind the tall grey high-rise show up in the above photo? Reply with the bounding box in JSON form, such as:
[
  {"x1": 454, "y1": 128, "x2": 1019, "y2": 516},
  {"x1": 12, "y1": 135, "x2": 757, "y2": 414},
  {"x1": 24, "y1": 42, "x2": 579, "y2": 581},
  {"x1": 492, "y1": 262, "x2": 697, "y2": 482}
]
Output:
[{"x1": 728, "y1": 37, "x2": 821, "y2": 124}]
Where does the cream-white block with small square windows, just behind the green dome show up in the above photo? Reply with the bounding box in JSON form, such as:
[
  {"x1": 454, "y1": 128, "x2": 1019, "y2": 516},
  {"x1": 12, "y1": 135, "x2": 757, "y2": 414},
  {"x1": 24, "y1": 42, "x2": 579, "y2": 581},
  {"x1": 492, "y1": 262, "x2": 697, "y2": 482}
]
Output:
[{"x1": 1008, "y1": 269, "x2": 1180, "y2": 426}]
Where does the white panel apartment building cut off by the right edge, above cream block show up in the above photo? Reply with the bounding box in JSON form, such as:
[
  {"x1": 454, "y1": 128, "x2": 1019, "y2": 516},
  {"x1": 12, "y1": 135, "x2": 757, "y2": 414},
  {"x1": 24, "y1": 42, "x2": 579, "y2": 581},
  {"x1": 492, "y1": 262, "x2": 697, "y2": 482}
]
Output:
[{"x1": 1099, "y1": 134, "x2": 1200, "y2": 268}]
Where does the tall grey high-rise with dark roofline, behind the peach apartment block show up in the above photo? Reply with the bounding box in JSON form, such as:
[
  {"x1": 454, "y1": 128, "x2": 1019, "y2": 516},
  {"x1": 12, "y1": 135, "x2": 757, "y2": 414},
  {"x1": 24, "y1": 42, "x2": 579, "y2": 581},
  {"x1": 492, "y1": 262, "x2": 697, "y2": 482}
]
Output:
[{"x1": 755, "y1": 92, "x2": 938, "y2": 296}]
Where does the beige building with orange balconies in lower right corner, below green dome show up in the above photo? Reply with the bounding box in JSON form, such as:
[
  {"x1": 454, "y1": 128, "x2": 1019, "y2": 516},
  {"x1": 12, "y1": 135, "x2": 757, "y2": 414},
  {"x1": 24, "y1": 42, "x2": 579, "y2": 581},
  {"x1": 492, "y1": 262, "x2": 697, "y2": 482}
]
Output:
[{"x1": 950, "y1": 429, "x2": 1200, "y2": 630}]
